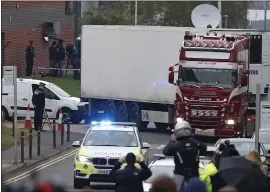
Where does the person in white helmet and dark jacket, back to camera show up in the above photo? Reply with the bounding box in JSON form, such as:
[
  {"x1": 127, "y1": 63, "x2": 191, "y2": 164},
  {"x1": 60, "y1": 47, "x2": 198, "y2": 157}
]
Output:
[{"x1": 163, "y1": 121, "x2": 207, "y2": 190}]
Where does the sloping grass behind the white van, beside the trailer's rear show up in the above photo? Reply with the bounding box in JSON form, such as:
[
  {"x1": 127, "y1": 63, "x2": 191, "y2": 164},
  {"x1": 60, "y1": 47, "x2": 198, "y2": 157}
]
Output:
[{"x1": 31, "y1": 75, "x2": 81, "y2": 97}]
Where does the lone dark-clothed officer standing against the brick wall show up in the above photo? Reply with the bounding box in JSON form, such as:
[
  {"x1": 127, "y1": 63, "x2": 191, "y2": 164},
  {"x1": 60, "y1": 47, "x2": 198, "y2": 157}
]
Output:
[{"x1": 25, "y1": 41, "x2": 36, "y2": 76}]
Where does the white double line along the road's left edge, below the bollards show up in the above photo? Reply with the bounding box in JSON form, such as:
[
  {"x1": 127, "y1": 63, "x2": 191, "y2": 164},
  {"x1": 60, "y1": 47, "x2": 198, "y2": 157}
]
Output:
[{"x1": 2, "y1": 149, "x2": 78, "y2": 185}]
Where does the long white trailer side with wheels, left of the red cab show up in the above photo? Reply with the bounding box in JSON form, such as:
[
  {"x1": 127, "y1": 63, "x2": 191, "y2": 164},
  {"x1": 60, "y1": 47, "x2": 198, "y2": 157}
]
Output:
[{"x1": 81, "y1": 25, "x2": 206, "y2": 130}]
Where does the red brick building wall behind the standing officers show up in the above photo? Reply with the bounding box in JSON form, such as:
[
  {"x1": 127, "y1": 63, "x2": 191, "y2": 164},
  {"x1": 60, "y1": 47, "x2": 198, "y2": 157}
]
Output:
[{"x1": 2, "y1": 1, "x2": 75, "y2": 76}]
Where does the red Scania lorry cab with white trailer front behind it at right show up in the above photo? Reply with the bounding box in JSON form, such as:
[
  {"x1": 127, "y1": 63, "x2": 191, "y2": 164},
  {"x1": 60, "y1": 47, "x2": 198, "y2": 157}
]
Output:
[{"x1": 168, "y1": 29, "x2": 270, "y2": 137}]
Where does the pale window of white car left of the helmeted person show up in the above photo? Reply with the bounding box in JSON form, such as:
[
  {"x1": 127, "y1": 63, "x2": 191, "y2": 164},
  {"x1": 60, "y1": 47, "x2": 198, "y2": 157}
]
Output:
[{"x1": 145, "y1": 166, "x2": 174, "y2": 183}]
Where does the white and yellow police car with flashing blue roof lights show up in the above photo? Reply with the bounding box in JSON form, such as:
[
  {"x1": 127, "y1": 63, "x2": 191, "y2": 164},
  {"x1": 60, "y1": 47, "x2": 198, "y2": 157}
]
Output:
[{"x1": 72, "y1": 122, "x2": 150, "y2": 189}]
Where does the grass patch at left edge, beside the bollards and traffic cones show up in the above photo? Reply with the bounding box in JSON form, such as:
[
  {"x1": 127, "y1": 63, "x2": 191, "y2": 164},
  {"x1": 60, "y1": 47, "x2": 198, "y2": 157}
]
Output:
[{"x1": 1, "y1": 123, "x2": 37, "y2": 151}]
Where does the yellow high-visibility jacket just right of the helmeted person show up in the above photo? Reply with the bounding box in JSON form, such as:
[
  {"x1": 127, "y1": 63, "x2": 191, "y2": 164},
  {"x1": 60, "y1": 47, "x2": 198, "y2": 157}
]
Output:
[{"x1": 199, "y1": 163, "x2": 218, "y2": 192}]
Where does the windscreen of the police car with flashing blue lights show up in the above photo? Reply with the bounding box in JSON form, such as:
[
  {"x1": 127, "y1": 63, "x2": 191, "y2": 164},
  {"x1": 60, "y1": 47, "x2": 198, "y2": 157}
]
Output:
[{"x1": 83, "y1": 130, "x2": 138, "y2": 147}]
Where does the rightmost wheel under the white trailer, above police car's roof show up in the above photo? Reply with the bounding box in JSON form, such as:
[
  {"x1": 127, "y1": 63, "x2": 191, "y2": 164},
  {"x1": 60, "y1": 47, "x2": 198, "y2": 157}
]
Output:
[{"x1": 128, "y1": 103, "x2": 149, "y2": 131}]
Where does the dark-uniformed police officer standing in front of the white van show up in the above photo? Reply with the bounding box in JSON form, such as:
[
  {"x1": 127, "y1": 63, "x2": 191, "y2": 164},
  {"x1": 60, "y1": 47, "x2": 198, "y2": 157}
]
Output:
[{"x1": 32, "y1": 85, "x2": 45, "y2": 131}]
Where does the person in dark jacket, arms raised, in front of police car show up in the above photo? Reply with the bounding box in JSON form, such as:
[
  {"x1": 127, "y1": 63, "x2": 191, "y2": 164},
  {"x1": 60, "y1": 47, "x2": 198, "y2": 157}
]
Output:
[{"x1": 110, "y1": 153, "x2": 152, "y2": 192}]
